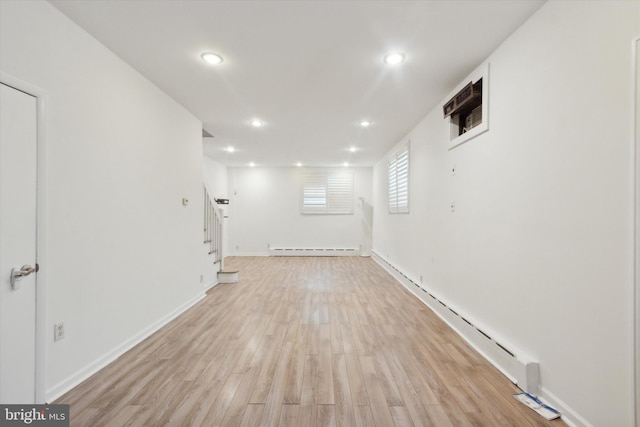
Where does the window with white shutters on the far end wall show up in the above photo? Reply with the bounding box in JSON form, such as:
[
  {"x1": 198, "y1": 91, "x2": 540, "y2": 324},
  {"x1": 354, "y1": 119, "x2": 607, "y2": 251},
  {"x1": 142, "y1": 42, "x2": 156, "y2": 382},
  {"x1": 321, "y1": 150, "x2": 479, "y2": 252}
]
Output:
[{"x1": 302, "y1": 172, "x2": 353, "y2": 214}]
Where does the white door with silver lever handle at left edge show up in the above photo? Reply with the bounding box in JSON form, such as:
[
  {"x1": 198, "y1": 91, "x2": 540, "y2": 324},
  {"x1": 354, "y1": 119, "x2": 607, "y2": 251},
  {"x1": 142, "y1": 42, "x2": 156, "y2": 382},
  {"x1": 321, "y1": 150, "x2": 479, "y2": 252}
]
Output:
[{"x1": 0, "y1": 84, "x2": 37, "y2": 404}]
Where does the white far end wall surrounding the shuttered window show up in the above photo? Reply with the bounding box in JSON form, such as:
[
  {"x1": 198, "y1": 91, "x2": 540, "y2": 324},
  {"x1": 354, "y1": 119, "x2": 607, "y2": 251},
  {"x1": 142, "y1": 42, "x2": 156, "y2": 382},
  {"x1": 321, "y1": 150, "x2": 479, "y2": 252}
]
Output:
[{"x1": 229, "y1": 167, "x2": 372, "y2": 255}]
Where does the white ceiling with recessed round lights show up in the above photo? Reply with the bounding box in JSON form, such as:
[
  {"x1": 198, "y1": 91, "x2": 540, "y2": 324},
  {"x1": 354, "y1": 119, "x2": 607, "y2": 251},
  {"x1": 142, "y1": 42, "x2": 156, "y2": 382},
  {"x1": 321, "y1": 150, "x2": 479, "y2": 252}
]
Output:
[{"x1": 50, "y1": 0, "x2": 544, "y2": 166}]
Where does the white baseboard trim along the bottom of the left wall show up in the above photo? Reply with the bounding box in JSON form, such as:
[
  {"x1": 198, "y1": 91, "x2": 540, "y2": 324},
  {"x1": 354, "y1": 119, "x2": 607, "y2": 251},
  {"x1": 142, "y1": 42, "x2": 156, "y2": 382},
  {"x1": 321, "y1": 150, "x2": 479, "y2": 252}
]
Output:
[{"x1": 45, "y1": 292, "x2": 205, "y2": 402}]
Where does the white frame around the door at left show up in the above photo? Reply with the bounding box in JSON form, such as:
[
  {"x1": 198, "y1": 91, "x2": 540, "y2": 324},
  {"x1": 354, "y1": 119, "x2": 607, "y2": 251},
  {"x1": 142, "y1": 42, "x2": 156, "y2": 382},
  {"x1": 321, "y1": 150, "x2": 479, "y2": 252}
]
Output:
[{"x1": 0, "y1": 71, "x2": 47, "y2": 404}]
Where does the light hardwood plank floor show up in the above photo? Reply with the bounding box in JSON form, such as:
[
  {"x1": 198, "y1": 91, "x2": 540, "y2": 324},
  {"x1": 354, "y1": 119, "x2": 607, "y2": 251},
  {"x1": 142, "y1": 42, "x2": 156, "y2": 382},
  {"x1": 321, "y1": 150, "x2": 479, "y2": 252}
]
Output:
[{"x1": 55, "y1": 257, "x2": 564, "y2": 427}]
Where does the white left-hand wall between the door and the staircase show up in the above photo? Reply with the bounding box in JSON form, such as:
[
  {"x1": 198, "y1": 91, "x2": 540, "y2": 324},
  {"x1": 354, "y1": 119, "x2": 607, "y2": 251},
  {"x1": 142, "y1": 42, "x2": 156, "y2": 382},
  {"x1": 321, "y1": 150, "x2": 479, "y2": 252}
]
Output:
[{"x1": 0, "y1": 1, "x2": 203, "y2": 401}]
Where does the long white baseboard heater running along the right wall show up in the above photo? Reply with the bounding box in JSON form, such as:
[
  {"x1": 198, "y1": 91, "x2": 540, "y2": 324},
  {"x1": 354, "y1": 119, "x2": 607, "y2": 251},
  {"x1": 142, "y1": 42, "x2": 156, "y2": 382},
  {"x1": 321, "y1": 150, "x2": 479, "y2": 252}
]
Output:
[{"x1": 372, "y1": 251, "x2": 540, "y2": 395}]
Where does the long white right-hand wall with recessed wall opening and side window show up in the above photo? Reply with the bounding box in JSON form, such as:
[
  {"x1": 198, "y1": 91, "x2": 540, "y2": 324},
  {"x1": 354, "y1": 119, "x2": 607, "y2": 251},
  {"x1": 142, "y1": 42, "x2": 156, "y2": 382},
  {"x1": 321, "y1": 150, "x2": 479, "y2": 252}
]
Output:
[{"x1": 373, "y1": 1, "x2": 640, "y2": 426}]
